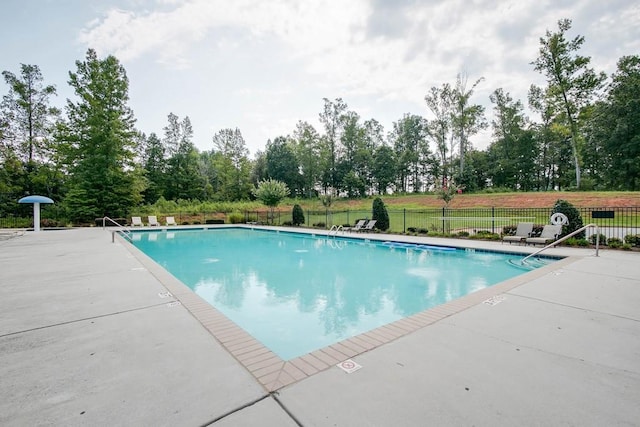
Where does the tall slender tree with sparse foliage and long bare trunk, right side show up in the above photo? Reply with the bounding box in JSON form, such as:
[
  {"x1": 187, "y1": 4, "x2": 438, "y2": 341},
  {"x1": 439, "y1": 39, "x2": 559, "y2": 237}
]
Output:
[{"x1": 531, "y1": 19, "x2": 606, "y2": 188}]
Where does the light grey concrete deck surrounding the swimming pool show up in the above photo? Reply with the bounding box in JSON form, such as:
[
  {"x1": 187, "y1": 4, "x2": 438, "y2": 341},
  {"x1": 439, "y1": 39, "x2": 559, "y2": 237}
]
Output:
[{"x1": 0, "y1": 228, "x2": 640, "y2": 426}]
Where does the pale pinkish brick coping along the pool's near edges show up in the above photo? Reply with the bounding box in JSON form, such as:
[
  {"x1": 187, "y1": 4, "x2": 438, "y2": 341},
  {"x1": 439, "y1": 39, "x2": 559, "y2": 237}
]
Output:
[{"x1": 118, "y1": 232, "x2": 580, "y2": 392}]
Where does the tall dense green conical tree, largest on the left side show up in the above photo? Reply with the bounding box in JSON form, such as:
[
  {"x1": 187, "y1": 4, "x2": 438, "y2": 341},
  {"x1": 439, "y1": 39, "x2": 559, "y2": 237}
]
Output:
[{"x1": 57, "y1": 49, "x2": 142, "y2": 221}]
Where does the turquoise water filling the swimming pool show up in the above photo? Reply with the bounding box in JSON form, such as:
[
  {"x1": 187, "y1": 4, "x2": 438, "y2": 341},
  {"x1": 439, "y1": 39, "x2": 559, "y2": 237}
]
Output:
[{"x1": 133, "y1": 228, "x2": 556, "y2": 360}]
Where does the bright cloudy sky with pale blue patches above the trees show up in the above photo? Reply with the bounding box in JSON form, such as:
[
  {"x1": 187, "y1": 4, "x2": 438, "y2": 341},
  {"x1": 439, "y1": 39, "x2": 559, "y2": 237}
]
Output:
[{"x1": 0, "y1": 0, "x2": 640, "y2": 155}]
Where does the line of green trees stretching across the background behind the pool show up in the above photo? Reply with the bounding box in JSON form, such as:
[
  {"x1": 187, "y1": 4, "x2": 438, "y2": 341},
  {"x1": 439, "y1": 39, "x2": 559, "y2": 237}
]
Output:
[{"x1": 0, "y1": 19, "x2": 640, "y2": 221}]
